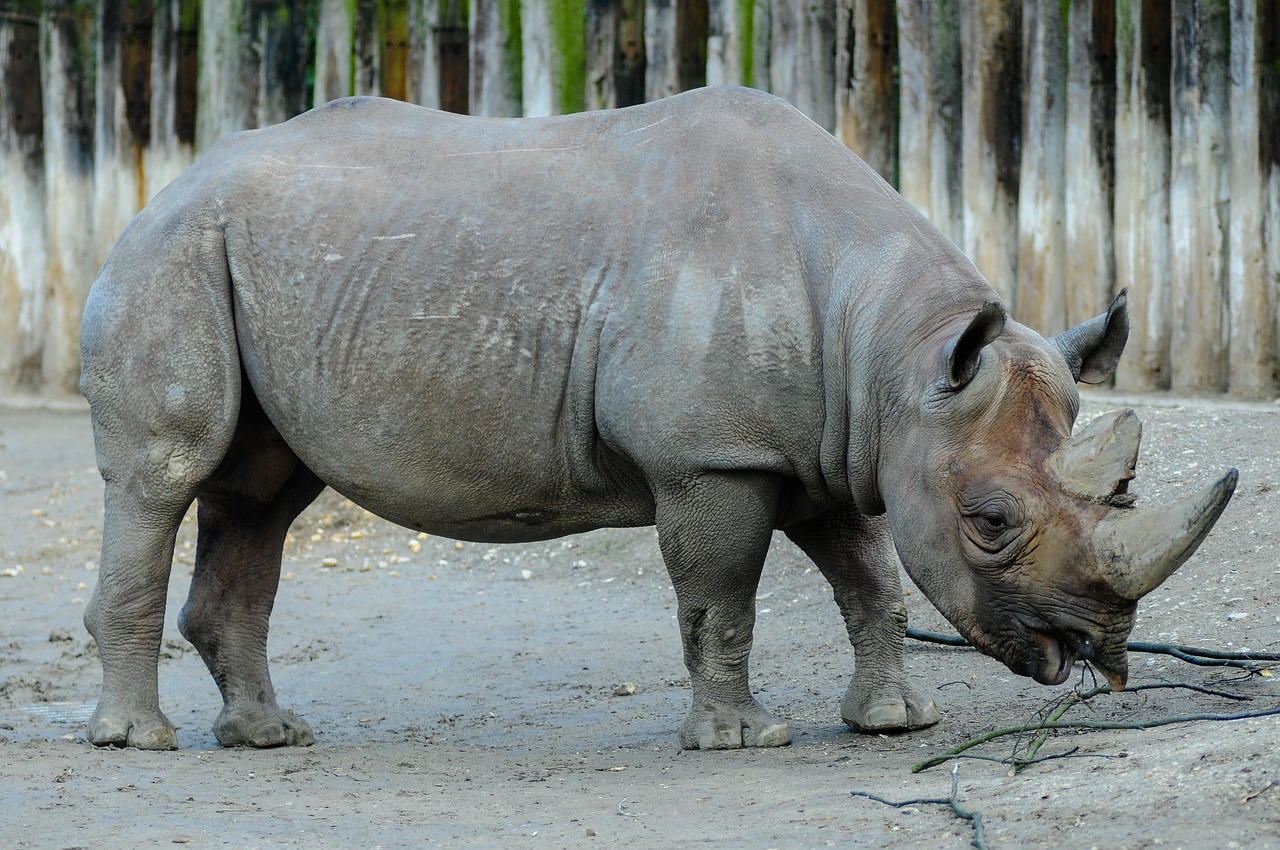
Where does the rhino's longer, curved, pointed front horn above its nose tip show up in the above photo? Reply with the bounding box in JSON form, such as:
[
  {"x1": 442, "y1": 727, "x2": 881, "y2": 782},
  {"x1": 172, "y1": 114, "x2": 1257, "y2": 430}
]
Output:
[{"x1": 1094, "y1": 469, "x2": 1239, "y2": 602}]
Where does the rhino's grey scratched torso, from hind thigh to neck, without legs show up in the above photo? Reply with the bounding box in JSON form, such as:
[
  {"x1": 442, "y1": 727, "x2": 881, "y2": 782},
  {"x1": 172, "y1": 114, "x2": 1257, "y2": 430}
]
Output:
[{"x1": 135, "y1": 91, "x2": 947, "y2": 539}]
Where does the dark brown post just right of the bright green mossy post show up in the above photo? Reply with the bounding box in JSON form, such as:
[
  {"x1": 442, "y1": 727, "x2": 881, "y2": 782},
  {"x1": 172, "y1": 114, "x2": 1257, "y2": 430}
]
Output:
[{"x1": 585, "y1": 0, "x2": 645, "y2": 109}]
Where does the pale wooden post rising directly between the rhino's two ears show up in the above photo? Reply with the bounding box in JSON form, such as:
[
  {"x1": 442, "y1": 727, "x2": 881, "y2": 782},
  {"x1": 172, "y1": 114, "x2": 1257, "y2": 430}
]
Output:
[{"x1": 1014, "y1": 0, "x2": 1066, "y2": 334}]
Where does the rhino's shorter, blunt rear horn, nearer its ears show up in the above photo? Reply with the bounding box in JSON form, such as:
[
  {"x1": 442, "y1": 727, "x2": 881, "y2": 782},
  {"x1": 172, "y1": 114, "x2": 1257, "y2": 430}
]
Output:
[{"x1": 1048, "y1": 410, "x2": 1142, "y2": 504}]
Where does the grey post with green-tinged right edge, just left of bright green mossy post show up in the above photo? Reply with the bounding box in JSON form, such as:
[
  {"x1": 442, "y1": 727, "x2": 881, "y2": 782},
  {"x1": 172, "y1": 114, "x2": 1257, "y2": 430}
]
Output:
[{"x1": 471, "y1": 0, "x2": 522, "y2": 118}]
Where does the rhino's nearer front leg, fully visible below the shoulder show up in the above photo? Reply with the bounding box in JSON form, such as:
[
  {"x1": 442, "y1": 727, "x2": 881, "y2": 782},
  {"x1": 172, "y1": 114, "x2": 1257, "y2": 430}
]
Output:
[{"x1": 657, "y1": 474, "x2": 791, "y2": 750}]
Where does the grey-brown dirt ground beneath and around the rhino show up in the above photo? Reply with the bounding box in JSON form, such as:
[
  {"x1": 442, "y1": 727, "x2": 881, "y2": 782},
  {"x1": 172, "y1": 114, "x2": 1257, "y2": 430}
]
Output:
[{"x1": 0, "y1": 394, "x2": 1280, "y2": 850}]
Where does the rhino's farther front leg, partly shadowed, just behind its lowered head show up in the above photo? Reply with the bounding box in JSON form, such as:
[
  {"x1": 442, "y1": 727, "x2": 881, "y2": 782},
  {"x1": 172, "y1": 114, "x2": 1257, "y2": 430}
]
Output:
[{"x1": 786, "y1": 508, "x2": 940, "y2": 732}]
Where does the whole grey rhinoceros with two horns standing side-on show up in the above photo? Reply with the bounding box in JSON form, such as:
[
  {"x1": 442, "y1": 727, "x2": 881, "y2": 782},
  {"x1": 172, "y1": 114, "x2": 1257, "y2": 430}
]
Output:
[{"x1": 81, "y1": 88, "x2": 1236, "y2": 749}]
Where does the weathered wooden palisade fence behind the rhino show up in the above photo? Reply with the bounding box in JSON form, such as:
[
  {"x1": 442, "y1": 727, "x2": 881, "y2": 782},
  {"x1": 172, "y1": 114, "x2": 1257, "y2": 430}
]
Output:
[{"x1": 0, "y1": 0, "x2": 1280, "y2": 397}]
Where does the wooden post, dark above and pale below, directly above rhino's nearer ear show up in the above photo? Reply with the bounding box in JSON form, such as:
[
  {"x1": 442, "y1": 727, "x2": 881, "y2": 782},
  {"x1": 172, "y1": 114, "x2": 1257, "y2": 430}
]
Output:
[{"x1": 960, "y1": 0, "x2": 1023, "y2": 305}]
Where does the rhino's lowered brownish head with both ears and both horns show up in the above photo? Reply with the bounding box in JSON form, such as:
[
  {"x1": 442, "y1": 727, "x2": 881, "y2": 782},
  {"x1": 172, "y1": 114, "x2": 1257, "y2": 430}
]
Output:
[{"x1": 879, "y1": 293, "x2": 1236, "y2": 690}]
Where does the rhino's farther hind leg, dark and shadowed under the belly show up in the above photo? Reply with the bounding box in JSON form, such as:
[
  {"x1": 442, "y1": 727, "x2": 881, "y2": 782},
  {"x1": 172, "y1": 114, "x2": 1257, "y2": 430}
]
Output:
[{"x1": 178, "y1": 392, "x2": 324, "y2": 748}]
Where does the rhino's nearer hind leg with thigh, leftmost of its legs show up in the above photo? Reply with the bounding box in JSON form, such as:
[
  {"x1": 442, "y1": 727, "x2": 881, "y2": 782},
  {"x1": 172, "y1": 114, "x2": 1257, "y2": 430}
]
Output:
[{"x1": 81, "y1": 249, "x2": 239, "y2": 749}]
